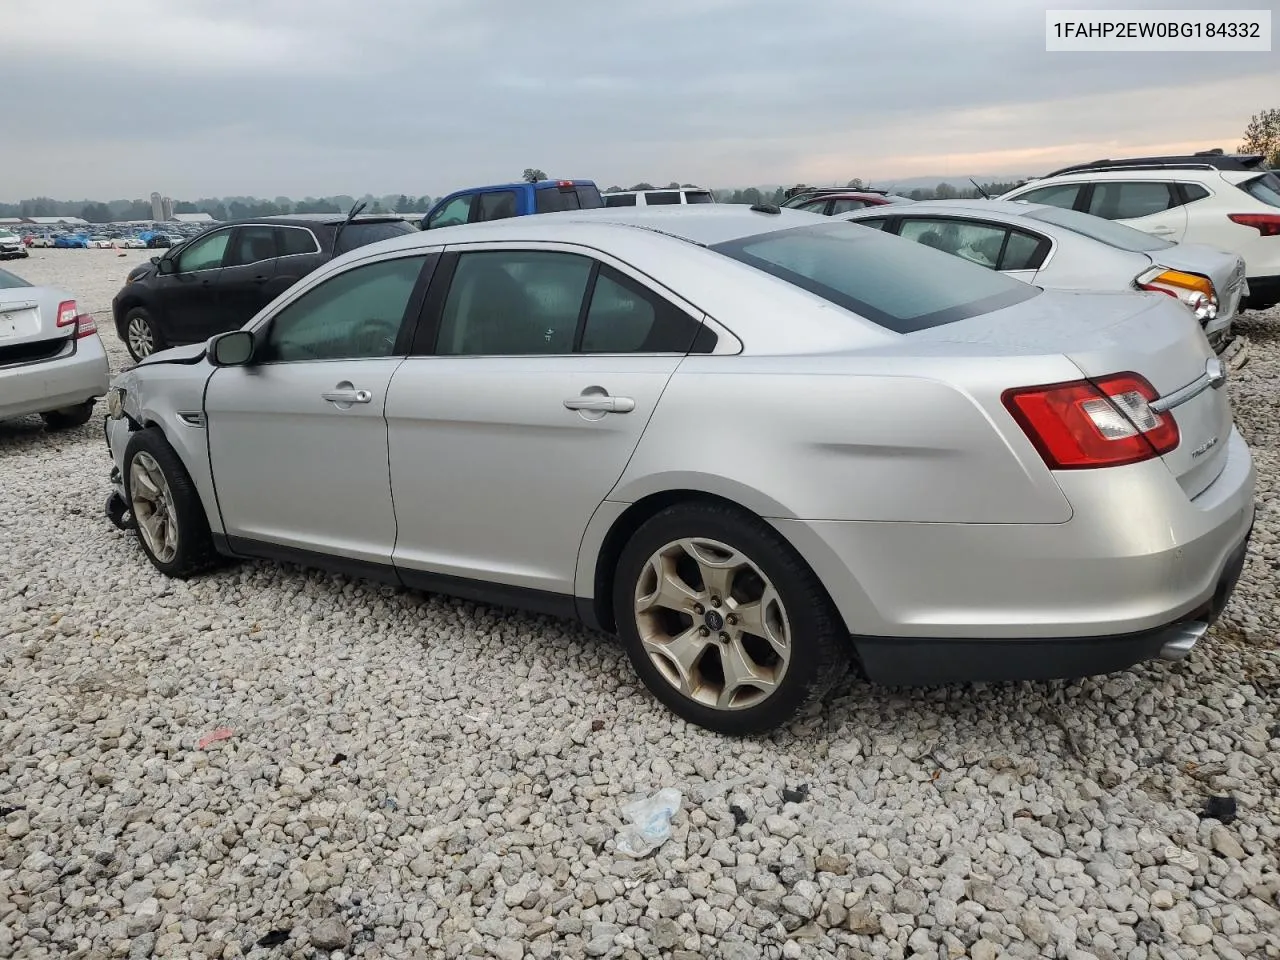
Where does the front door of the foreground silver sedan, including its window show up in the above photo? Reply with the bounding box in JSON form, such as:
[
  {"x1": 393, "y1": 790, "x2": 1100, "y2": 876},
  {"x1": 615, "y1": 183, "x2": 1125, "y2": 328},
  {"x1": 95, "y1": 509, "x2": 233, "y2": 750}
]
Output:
[{"x1": 205, "y1": 252, "x2": 434, "y2": 575}]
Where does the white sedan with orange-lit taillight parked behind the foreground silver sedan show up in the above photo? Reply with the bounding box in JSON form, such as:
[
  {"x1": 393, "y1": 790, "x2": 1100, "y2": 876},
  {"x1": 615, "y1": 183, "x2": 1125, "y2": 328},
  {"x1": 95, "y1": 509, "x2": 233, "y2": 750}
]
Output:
[{"x1": 844, "y1": 200, "x2": 1244, "y2": 349}]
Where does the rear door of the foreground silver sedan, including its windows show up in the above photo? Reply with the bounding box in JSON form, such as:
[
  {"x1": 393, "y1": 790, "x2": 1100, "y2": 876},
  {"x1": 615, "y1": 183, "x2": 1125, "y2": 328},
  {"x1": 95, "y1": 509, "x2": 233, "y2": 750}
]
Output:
[{"x1": 387, "y1": 244, "x2": 701, "y2": 603}]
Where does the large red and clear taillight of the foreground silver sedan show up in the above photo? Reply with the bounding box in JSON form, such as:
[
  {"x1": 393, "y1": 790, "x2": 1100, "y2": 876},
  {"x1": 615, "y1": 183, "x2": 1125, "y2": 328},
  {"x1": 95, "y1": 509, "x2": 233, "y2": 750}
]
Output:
[{"x1": 1001, "y1": 374, "x2": 1179, "y2": 470}]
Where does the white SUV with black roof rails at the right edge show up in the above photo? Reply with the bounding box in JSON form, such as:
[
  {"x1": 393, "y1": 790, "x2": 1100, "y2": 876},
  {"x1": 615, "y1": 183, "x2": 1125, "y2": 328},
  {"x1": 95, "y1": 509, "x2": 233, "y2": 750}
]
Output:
[{"x1": 1001, "y1": 151, "x2": 1280, "y2": 310}]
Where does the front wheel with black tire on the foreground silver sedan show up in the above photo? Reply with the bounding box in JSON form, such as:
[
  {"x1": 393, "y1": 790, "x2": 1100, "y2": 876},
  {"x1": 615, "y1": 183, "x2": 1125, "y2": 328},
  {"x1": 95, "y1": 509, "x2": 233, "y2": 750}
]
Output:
[{"x1": 122, "y1": 426, "x2": 218, "y2": 580}]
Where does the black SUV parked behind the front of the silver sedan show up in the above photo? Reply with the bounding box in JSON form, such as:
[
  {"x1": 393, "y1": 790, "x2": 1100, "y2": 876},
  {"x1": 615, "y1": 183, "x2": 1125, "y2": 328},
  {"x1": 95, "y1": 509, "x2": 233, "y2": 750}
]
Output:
[{"x1": 111, "y1": 214, "x2": 417, "y2": 360}]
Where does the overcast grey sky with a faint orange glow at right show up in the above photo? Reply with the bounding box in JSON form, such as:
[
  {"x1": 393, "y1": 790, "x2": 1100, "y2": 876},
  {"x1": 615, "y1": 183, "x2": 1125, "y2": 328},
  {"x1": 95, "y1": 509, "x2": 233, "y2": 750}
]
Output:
[{"x1": 0, "y1": 0, "x2": 1280, "y2": 201}]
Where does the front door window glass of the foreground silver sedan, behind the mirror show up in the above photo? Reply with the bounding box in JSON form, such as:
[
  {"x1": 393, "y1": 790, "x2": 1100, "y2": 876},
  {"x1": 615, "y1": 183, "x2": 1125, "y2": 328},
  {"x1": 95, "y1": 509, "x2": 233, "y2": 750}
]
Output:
[{"x1": 262, "y1": 256, "x2": 426, "y2": 362}]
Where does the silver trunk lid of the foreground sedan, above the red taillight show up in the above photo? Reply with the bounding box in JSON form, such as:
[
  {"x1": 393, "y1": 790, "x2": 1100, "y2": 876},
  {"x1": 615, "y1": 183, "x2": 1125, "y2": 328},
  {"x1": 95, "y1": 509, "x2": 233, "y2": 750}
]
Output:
[{"x1": 909, "y1": 291, "x2": 1231, "y2": 498}]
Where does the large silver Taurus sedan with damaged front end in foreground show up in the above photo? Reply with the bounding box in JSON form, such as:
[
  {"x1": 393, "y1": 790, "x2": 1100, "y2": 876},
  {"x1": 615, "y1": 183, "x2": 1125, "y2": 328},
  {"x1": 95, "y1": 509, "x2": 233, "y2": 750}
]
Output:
[{"x1": 99, "y1": 205, "x2": 1254, "y2": 733}]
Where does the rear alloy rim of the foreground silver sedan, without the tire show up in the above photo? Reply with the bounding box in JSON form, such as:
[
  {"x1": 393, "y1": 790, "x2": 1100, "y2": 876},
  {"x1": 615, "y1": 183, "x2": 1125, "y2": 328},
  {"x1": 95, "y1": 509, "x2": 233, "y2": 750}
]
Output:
[{"x1": 635, "y1": 538, "x2": 791, "y2": 710}]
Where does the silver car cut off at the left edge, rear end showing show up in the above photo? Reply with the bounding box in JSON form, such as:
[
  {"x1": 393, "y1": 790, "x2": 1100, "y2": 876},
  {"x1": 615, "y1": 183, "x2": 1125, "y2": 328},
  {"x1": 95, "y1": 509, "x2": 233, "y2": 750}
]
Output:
[{"x1": 0, "y1": 264, "x2": 110, "y2": 430}]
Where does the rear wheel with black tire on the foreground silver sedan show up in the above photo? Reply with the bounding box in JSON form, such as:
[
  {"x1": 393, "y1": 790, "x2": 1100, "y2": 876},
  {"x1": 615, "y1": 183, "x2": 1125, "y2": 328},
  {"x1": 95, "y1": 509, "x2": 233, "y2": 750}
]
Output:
[{"x1": 612, "y1": 503, "x2": 851, "y2": 736}]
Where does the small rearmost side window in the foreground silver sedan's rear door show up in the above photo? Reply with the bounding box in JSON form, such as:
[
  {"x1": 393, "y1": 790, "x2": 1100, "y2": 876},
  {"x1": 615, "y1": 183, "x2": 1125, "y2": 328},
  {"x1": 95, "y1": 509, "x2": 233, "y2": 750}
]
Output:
[{"x1": 581, "y1": 266, "x2": 700, "y2": 353}]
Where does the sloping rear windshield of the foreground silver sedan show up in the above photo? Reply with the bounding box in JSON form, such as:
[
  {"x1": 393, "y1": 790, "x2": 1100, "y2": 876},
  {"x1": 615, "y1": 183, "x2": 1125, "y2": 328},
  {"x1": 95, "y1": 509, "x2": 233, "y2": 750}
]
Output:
[{"x1": 712, "y1": 221, "x2": 1041, "y2": 333}]
